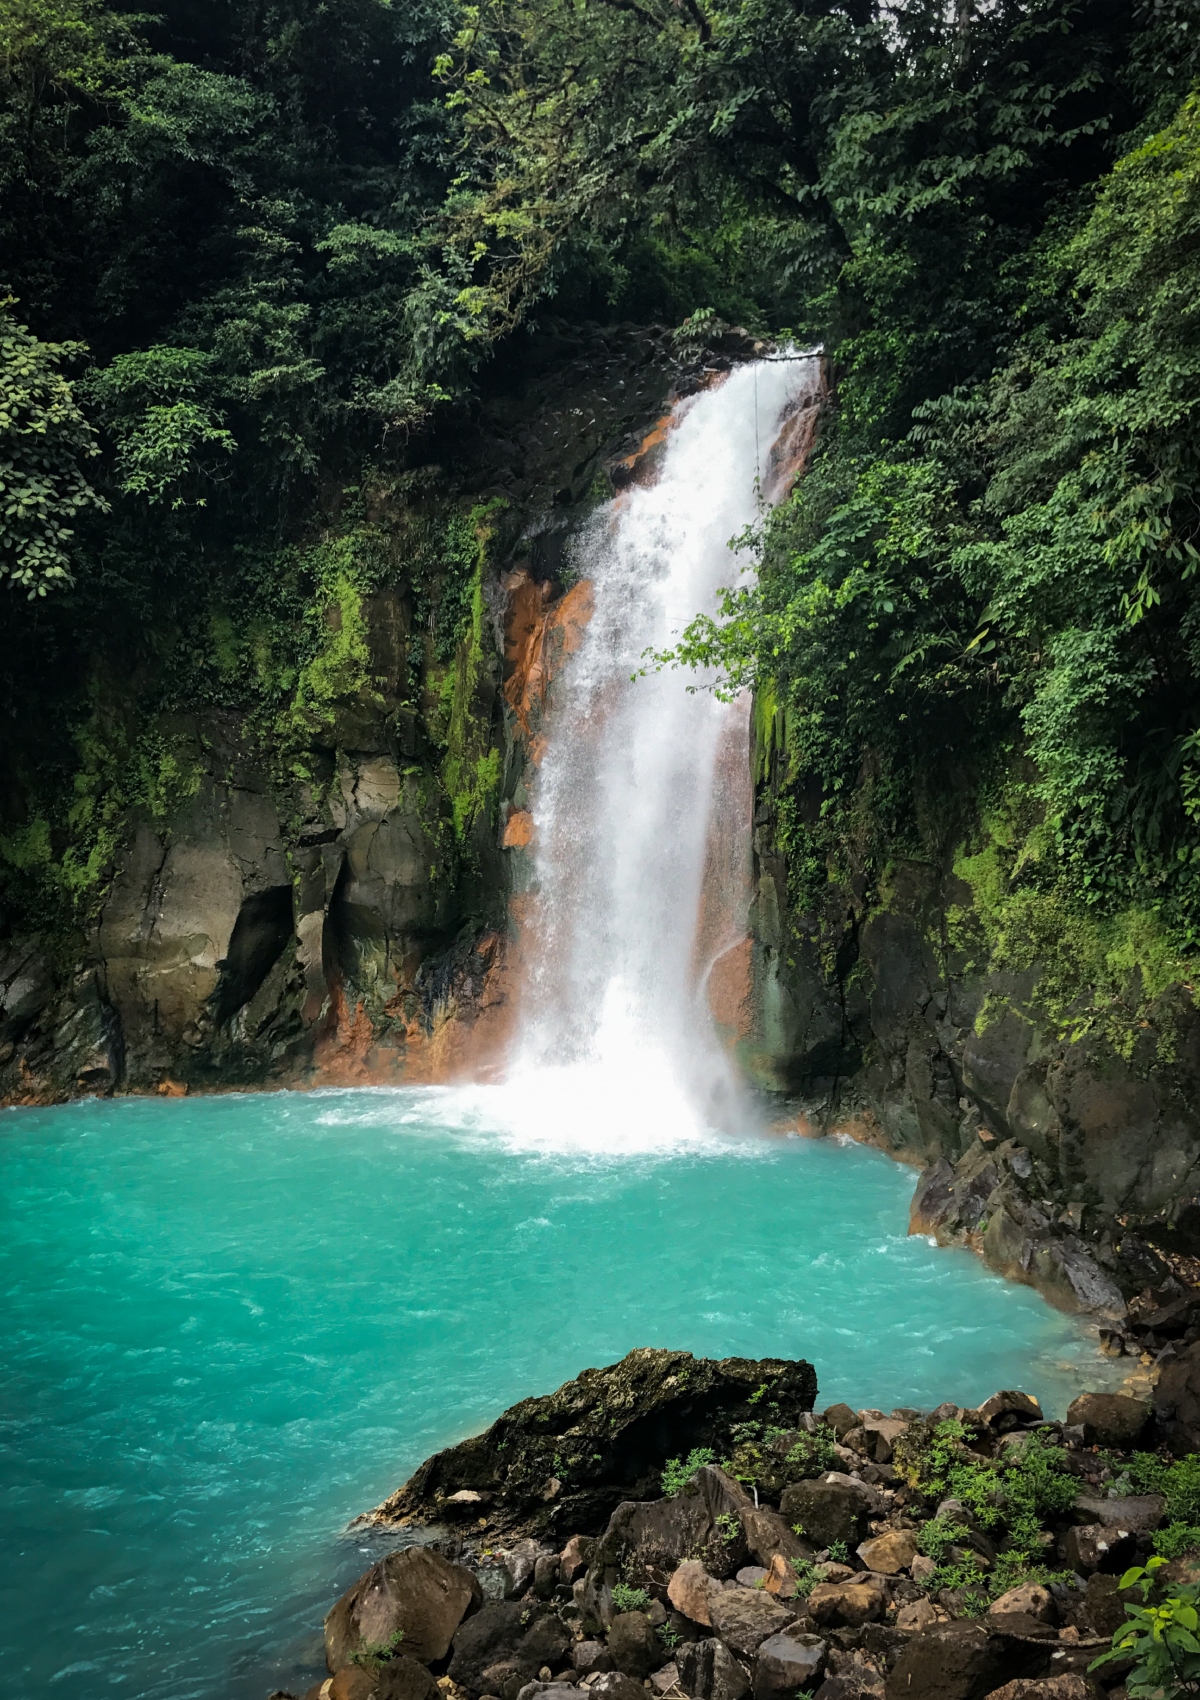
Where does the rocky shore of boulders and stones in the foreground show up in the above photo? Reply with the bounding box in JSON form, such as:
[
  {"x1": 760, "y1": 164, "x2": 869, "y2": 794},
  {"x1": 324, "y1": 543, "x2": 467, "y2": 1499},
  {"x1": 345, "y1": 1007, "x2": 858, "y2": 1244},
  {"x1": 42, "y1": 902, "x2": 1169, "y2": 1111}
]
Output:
[{"x1": 272, "y1": 1345, "x2": 1200, "y2": 1700}]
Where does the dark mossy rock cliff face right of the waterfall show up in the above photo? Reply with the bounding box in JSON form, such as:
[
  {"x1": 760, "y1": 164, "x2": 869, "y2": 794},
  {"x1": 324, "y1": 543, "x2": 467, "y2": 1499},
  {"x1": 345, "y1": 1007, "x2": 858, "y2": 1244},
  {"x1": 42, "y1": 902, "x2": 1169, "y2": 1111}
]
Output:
[{"x1": 739, "y1": 778, "x2": 1200, "y2": 1350}]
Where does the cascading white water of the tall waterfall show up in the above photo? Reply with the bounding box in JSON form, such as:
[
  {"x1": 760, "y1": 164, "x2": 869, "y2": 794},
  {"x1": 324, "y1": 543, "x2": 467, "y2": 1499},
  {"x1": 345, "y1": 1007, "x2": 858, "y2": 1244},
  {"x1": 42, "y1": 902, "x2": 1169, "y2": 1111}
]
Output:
[{"x1": 510, "y1": 359, "x2": 818, "y2": 1142}]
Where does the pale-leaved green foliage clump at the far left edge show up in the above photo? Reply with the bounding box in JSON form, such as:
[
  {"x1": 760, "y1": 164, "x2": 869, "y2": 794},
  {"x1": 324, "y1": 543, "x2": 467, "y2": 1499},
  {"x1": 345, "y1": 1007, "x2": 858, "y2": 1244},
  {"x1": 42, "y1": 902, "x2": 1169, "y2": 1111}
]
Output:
[{"x1": 0, "y1": 301, "x2": 105, "y2": 597}]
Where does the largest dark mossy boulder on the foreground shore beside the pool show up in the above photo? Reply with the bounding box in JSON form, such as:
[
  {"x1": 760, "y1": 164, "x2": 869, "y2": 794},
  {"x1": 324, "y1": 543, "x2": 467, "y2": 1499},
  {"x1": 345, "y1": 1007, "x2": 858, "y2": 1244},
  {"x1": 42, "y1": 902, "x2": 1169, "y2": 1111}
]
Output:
[{"x1": 363, "y1": 1348, "x2": 816, "y2": 1561}]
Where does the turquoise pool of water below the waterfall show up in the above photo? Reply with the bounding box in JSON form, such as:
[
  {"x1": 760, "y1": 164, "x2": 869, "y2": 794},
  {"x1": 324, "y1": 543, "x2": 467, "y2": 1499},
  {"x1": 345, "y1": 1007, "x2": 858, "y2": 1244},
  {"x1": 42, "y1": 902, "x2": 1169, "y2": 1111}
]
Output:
[{"x1": 0, "y1": 1086, "x2": 1103, "y2": 1700}]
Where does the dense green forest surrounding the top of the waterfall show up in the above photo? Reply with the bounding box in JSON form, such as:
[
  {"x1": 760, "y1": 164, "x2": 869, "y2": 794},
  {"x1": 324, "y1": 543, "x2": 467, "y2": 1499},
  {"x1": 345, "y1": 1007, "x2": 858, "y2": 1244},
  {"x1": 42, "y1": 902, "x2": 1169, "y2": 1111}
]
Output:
[{"x1": 0, "y1": 0, "x2": 1200, "y2": 1010}]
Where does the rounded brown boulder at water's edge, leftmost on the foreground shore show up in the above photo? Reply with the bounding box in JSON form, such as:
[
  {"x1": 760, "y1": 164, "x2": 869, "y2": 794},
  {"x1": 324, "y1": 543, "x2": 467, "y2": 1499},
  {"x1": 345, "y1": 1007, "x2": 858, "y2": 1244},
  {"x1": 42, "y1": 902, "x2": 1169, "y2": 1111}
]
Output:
[{"x1": 325, "y1": 1547, "x2": 483, "y2": 1671}]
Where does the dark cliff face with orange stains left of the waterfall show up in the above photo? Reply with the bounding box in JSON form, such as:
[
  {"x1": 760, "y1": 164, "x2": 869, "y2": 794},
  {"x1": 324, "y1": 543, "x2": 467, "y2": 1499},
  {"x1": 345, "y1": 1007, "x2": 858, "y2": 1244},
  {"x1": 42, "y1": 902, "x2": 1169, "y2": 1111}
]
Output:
[{"x1": 0, "y1": 326, "x2": 696, "y2": 1103}]
